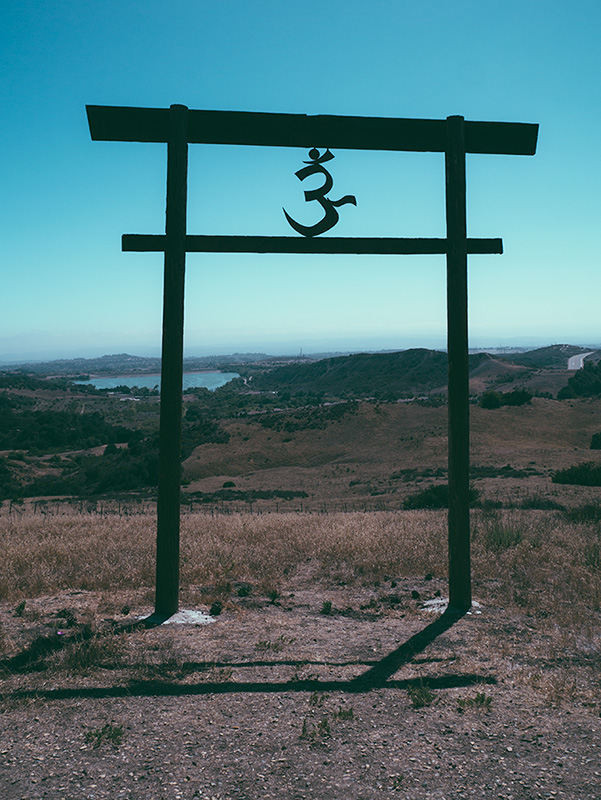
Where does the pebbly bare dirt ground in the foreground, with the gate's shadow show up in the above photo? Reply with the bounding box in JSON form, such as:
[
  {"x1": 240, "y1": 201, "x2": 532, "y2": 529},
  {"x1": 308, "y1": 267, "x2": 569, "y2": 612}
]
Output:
[{"x1": 0, "y1": 574, "x2": 601, "y2": 800}]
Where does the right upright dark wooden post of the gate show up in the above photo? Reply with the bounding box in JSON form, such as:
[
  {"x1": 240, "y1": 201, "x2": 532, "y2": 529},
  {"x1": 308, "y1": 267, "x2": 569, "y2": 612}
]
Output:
[{"x1": 445, "y1": 117, "x2": 472, "y2": 611}]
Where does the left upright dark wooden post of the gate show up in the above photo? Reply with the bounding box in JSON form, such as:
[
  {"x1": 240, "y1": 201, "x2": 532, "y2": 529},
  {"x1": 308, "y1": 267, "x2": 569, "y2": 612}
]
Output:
[{"x1": 155, "y1": 105, "x2": 188, "y2": 617}]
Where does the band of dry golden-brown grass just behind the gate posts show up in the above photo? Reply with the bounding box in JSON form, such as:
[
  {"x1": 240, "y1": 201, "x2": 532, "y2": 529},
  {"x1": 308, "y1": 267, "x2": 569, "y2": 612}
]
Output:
[{"x1": 0, "y1": 510, "x2": 601, "y2": 632}]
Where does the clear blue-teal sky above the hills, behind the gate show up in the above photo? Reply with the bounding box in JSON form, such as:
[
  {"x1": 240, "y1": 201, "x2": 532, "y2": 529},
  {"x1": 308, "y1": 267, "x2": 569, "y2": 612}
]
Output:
[{"x1": 0, "y1": 0, "x2": 601, "y2": 362}]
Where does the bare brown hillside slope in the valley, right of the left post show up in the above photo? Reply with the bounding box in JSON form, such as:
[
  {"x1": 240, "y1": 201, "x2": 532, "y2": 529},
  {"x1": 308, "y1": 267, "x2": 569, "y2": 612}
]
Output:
[{"x1": 184, "y1": 398, "x2": 601, "y2": 507}]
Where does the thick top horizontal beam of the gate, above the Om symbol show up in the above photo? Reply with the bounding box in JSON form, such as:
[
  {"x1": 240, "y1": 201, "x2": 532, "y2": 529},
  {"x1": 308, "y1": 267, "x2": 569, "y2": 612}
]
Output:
[{"x1": 86, "y1": 106, "x2": 538, "y2": 156}]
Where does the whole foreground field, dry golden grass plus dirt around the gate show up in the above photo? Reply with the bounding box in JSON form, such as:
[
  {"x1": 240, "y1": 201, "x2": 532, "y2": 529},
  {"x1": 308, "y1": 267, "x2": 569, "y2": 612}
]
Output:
[{"x1": 0, "y1": 510, "x2": 601, "y2": 800}]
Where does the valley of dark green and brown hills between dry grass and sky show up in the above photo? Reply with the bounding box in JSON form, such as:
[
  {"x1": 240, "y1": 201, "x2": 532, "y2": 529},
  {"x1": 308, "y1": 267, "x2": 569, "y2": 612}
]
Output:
[{"x1": 0, "y1": 345, "x2": 601, "y2": 510}]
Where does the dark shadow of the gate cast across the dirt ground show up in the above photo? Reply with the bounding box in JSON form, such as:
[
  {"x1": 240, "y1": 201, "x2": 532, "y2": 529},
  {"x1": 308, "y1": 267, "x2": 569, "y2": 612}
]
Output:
[{"x1": 0, "y1": 610, "x2": 496, "y2": 700}]
